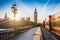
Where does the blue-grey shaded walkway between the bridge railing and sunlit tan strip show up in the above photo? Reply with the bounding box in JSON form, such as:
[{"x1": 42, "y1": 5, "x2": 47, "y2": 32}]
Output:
[{"x1": 7, "y1": 27, "x2": 40, "y2": 40}]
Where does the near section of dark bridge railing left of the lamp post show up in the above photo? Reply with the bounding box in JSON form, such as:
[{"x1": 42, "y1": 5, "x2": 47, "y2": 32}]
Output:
[{"x1": 0, "y1": 30, "x2": 15, "y2": 40}]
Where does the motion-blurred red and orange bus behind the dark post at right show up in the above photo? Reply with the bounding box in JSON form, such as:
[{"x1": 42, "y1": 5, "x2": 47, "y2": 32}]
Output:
[{"x1": 45, "y1": 11, "x2": 60, "y2": 36}]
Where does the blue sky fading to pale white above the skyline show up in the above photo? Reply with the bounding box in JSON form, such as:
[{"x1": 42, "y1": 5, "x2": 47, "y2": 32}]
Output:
[{"x1": 0, "y1": 0, "x2": 60, "y2": 22}]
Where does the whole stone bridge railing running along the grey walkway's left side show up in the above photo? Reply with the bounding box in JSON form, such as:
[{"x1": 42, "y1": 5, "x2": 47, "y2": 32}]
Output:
[{"x1": 0, "y1": 26, "x2": 32, "y2": 40}]
